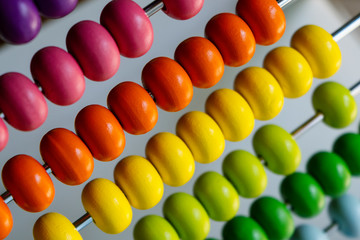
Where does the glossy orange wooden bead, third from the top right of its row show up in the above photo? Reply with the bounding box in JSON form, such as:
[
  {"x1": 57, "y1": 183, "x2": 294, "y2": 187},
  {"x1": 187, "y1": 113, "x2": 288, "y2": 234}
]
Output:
[{"x1": 175, "y1": 37, "x2": 224, "y2": 88}]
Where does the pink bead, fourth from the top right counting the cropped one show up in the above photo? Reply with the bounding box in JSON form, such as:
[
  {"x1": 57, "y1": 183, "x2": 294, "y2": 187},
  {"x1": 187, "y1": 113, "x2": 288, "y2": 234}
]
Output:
[{"x1": 30, "y1": 47, "x2": 85, "y2": 106}]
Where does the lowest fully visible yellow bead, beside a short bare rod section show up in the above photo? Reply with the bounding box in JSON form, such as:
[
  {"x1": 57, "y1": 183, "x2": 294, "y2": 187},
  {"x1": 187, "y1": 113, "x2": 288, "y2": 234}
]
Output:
[{"x1": 81, "y1": 178, "x2": 132, "y2": 234}]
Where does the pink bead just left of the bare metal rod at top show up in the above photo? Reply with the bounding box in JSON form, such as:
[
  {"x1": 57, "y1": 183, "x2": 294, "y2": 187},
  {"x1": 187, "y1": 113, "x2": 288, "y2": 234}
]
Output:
[{"x1": 100, "y1": 0, "x2": 154, "y2": 58}]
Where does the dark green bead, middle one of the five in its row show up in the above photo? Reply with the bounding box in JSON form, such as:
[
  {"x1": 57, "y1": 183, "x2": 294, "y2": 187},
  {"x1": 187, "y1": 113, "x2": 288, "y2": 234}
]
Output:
[{"x1": 280, "y1": 172, "x2": 325, "y2": 217}]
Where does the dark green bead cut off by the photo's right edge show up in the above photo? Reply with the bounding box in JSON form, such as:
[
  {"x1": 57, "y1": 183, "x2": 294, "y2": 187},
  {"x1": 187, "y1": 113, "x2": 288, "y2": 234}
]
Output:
[{"x1": 333, "y1": 133, "x2": 360, "y2": 176}]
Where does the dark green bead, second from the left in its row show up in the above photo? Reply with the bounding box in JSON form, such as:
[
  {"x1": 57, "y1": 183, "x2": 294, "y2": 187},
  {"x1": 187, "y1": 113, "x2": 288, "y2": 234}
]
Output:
[{"x1": 250, "y1": 197, "x2": 294, "y2": 240}]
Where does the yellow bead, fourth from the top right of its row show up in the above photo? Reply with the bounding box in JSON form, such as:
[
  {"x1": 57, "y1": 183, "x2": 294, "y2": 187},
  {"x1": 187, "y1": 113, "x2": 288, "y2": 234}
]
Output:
[{"x1": 205, "y1": 89, "x2": 255, "y2": 142}]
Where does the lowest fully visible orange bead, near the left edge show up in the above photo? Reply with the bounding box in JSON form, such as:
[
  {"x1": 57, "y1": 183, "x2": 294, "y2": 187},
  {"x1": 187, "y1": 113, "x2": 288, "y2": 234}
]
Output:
[{"x1": 2, "y1": 155, "x2": 55, "y2": 212}]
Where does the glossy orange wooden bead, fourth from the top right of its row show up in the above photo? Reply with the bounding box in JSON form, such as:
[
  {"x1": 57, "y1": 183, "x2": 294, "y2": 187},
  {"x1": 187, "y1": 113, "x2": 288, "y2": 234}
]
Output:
[{"x1": 141, "y1": 57, "x2": 193, "y2": 112}]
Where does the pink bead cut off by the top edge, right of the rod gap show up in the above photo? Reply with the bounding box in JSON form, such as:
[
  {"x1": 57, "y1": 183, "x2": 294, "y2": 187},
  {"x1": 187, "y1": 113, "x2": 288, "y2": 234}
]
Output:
[{"x1": 163, "y1": 0, "x2": 204, "y2": 20}]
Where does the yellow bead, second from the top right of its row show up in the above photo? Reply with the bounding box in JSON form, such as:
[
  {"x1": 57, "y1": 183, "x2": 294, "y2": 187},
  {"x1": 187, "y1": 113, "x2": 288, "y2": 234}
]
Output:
[{"x1": 264, "y1": 47, "x2": 313, "y2": 98}]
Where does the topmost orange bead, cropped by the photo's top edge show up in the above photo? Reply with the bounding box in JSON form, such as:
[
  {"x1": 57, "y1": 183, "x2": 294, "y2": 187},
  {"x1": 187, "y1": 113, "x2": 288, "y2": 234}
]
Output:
[{"x1": 236, "y1": 0, "x2": 286, "y2": 45}]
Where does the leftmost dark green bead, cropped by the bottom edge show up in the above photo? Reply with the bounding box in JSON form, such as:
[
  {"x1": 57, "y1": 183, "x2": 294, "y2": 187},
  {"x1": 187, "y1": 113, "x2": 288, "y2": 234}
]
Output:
[{"x1": 222, "y1": 216, "x2": 268, "y2": 240}]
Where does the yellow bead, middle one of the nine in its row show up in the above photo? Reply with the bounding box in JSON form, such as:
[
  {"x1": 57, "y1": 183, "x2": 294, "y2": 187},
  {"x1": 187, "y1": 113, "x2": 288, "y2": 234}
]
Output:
[{"x1": 176, "y1": 111, "x2": 225, "y2": 163}]
